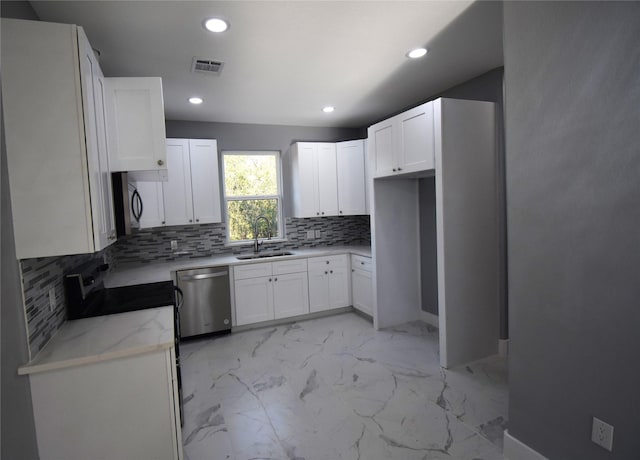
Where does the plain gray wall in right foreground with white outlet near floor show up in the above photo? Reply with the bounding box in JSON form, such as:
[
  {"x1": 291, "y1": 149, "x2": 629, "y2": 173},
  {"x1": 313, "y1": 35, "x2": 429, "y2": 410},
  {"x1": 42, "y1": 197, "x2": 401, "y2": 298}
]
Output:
[{"x1": 504, "y1": 2, "x2": 640, "y2": 460}]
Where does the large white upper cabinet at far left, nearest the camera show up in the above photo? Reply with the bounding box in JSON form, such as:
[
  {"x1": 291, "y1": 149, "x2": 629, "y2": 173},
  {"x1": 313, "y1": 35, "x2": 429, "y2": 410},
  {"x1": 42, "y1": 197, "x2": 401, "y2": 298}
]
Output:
[{"x1": 1, "y1": 19, "x2": 116, "y2": 259}]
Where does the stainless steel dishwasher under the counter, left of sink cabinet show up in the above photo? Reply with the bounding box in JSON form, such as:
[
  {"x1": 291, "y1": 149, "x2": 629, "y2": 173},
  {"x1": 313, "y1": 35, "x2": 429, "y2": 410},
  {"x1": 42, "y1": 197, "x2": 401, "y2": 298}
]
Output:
[{"x1": 177, "y1": 267, "x2": 231, "y2": 338}]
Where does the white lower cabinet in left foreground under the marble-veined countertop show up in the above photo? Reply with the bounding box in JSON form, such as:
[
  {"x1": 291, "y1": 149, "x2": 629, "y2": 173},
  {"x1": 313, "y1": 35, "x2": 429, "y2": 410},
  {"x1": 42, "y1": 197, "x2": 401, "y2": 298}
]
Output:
[{"x1": 29, "y1": 348, "x2": 182, "y2": 460}]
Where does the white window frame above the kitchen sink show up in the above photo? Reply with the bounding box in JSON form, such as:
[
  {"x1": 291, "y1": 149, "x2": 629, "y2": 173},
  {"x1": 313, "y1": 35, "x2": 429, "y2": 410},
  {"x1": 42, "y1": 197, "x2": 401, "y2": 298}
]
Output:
[{"x1": 221, "y1": 150, "x2": 286, "y2": 246}]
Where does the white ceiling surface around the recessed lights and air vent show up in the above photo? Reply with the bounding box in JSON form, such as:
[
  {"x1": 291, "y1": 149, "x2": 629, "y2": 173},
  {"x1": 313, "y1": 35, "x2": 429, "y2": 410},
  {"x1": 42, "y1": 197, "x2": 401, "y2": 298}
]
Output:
[{"x1": 31, "y1": 0, "x2": 503, "y2": 127}]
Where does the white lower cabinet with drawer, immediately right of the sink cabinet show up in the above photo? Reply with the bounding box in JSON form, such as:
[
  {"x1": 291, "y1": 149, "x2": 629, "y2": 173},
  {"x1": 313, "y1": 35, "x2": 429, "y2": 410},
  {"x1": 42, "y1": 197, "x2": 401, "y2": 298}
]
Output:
[{"x1": 307, "y1": 254, "x2": 351, "y2": 313}]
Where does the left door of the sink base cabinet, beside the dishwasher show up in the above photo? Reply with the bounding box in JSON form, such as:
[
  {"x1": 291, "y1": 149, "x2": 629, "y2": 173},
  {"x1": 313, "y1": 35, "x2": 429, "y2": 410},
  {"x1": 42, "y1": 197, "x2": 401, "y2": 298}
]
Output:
[{"x1": 235, "y1": 276, "x2": 274, "y2": 326}]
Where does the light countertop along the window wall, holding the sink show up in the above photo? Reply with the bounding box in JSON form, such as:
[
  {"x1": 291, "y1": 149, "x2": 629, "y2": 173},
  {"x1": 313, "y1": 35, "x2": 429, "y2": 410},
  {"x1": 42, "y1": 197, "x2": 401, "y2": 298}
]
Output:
[{"x1": 104, "y1": 246, "x2": 371, "y2": 287}]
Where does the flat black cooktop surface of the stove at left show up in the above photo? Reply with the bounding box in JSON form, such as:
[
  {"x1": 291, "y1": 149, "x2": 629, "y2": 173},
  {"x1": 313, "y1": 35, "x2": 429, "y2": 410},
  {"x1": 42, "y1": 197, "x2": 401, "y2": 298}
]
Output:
[{"x1": 68, "y1": 281, "x2": 176, "y2": 319}]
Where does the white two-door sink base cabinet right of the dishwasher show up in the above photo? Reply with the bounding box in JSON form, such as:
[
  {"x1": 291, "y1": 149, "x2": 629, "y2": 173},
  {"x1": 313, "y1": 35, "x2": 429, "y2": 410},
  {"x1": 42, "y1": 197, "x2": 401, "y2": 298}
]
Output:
[{"x1": 233, "y1": 259, "x2": 309, "y2": 326}]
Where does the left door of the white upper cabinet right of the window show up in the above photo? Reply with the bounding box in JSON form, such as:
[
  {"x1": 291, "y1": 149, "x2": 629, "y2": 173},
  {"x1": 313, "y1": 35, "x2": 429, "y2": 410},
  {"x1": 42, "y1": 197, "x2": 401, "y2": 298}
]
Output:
[{"x1": 293, "y1": 142, "x2": 320, "y2": 217}]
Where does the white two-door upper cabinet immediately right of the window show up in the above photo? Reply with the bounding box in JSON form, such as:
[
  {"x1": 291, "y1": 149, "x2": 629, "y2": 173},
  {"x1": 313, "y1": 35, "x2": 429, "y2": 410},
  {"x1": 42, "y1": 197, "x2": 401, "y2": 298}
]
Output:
[{"x1": 291, "y1": 142, "x2": 338, "y2": 217}]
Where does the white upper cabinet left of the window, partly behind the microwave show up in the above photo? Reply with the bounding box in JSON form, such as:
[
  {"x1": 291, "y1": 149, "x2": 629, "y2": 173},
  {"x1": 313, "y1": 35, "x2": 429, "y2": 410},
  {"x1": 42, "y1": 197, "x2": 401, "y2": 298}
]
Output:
[{"x1": 129, "y1": 139, "x2": 222, "y2": 228}]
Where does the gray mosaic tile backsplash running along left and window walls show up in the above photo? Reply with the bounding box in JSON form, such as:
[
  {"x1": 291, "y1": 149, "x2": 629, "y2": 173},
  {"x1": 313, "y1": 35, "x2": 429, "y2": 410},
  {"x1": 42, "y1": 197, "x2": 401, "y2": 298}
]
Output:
[{"x1": 20, "y1": 216, "x2": 371, "y2": 358}]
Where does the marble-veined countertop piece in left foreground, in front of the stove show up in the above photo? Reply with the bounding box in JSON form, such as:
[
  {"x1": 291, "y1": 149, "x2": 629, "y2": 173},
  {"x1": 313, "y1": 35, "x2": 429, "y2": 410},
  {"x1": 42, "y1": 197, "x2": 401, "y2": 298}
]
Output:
[{"x1": 18, "y1": 306, "x2": 175, "y2": 375}]
